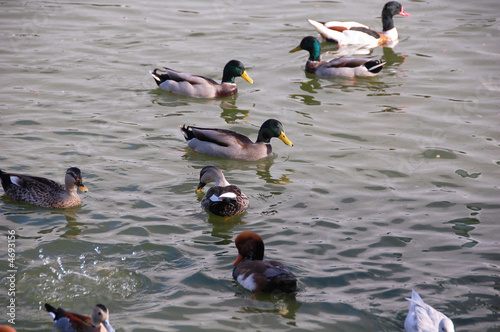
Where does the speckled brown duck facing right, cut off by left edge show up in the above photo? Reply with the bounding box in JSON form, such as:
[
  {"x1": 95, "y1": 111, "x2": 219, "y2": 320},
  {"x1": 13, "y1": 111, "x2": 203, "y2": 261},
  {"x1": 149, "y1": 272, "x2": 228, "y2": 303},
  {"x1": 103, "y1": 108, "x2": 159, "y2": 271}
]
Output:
[{"x1": 0, "y1": 167, "x2": 88, "y2": 208}]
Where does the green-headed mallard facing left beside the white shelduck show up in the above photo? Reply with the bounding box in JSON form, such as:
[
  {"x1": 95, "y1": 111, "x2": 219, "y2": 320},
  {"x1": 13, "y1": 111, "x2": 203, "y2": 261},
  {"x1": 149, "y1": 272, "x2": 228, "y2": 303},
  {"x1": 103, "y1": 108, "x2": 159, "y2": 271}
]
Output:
[{"x1": 290, "y1": 36, "x2": 385, "y2": 78}]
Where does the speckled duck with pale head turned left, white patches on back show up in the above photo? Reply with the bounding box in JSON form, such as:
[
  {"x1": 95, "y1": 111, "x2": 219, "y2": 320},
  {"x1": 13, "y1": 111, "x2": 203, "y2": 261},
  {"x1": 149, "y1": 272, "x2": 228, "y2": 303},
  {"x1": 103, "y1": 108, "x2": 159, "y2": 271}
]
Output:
[{"x1": 196, "y1": 166, "x2": 248, "y2": 217}]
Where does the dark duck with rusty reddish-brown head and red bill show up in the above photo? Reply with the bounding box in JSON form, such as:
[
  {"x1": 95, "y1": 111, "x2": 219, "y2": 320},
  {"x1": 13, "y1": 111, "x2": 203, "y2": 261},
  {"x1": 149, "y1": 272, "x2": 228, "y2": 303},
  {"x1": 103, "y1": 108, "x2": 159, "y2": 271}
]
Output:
[{"x1": 233, "y1": 231, "x2": 297, "y2": 293}]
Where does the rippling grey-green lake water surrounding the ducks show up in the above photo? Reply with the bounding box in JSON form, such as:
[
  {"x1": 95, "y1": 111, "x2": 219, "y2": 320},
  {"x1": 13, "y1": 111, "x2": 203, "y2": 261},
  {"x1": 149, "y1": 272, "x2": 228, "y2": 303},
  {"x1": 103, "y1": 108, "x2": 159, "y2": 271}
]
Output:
[{"x1": 0, "y1": 0, "x2": 500, "y2": 331}]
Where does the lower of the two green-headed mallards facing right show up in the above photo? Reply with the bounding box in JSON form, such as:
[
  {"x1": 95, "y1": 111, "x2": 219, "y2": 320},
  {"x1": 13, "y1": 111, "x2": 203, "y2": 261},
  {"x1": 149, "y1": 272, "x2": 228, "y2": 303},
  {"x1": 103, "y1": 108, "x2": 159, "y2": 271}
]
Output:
[{"x1": 180, "y1": 119, "x2": 293, "y2": 161}]
